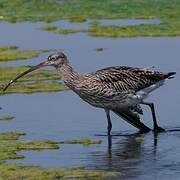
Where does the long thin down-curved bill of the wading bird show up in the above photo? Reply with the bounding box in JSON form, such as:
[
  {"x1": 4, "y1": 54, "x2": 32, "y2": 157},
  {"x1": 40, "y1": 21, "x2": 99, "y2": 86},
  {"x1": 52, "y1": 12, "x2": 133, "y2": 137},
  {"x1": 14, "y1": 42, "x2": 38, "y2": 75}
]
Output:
[{"x1": 3, "y1": 61, "x2": 48, "y2": 91}]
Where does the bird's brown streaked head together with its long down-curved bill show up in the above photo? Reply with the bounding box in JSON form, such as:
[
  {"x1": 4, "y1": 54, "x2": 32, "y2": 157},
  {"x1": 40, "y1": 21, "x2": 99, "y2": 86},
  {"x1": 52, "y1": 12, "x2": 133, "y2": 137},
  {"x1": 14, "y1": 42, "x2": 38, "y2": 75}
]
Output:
[{"x1": 3, "y1": 51, "x2": 68, "y2": 91}]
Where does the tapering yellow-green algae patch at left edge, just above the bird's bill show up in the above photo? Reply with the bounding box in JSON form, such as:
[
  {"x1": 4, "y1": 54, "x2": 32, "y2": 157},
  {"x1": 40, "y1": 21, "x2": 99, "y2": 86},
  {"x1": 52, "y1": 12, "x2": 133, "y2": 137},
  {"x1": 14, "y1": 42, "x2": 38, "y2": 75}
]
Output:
[{"x1": 0, "y1": 45, "x2": 49, "y2": 61}]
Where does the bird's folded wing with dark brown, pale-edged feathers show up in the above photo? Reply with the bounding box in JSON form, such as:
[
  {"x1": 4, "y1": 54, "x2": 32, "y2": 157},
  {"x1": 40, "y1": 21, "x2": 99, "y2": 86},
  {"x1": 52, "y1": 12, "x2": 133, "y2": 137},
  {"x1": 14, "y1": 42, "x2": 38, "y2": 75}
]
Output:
[{"x1": 95, "y1": 66, "x2": 168, "y2": 92}]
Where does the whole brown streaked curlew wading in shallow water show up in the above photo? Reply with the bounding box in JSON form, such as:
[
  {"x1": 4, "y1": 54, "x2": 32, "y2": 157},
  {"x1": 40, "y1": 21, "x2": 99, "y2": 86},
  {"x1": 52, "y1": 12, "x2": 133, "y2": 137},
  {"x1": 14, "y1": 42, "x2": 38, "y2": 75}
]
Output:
[{"x1": 4, "y1": 52, "x2": 176, "y2": 135}]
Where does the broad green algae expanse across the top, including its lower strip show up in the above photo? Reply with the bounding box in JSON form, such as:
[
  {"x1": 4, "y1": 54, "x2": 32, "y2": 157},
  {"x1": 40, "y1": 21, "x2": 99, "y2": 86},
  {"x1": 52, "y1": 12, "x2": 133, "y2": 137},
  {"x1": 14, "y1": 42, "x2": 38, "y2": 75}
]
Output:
[{"x1": 0, "y1": 0, "x2": 180, "y2": 37}]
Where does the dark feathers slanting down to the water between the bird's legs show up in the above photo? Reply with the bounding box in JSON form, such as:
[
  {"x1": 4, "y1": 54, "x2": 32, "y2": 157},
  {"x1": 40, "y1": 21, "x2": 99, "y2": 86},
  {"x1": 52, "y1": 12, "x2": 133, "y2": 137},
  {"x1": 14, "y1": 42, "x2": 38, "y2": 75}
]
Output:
[{"x1": 112, "y1": 109, "x2": 151, "y2": 133}]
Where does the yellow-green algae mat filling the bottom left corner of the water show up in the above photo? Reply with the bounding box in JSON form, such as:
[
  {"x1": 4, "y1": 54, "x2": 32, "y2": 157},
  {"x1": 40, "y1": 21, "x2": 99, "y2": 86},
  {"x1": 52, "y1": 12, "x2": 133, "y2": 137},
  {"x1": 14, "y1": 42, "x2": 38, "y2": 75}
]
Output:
[{"x1": 0, "y1": 131, "x2": 120, "y2": 180}]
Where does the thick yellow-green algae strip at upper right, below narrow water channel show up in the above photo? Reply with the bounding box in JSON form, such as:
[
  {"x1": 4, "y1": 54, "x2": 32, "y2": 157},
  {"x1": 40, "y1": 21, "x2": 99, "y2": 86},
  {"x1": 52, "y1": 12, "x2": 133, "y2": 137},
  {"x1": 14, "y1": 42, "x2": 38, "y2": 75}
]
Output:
[{"x1": 88, "y1": 23, "x2": 180, "y2": 38}]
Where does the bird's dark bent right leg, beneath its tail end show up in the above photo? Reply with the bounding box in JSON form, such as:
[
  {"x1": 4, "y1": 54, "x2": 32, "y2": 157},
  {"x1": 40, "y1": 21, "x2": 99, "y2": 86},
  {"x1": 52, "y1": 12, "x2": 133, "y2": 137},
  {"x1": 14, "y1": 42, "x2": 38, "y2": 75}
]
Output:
[{"x1": 142, "y1": 102, "x2": 165, "y2": 132}]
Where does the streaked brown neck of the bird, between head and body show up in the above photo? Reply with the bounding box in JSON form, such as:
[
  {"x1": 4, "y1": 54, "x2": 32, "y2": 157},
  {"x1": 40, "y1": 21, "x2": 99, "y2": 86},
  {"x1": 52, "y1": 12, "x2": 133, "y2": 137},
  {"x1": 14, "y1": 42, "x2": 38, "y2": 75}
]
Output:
[{"x1": 56, "y1": 62, "x2": 80, "y2": 90}]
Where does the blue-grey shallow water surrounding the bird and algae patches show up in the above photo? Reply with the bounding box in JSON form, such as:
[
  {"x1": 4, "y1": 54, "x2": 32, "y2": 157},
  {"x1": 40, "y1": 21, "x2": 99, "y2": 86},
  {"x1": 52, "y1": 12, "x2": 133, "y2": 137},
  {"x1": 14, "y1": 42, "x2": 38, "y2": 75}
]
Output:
[{"x1": 0, "y1": 20, "x2": 180, "y2": 180}]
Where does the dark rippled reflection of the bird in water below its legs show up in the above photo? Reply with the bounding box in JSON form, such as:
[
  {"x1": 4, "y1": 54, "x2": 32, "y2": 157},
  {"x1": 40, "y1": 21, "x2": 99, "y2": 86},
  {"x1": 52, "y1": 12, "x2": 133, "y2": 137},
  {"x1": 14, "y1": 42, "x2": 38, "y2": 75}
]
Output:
[{"x1": 88, "y1": 133, "x2": 158, "y2": 177}]
